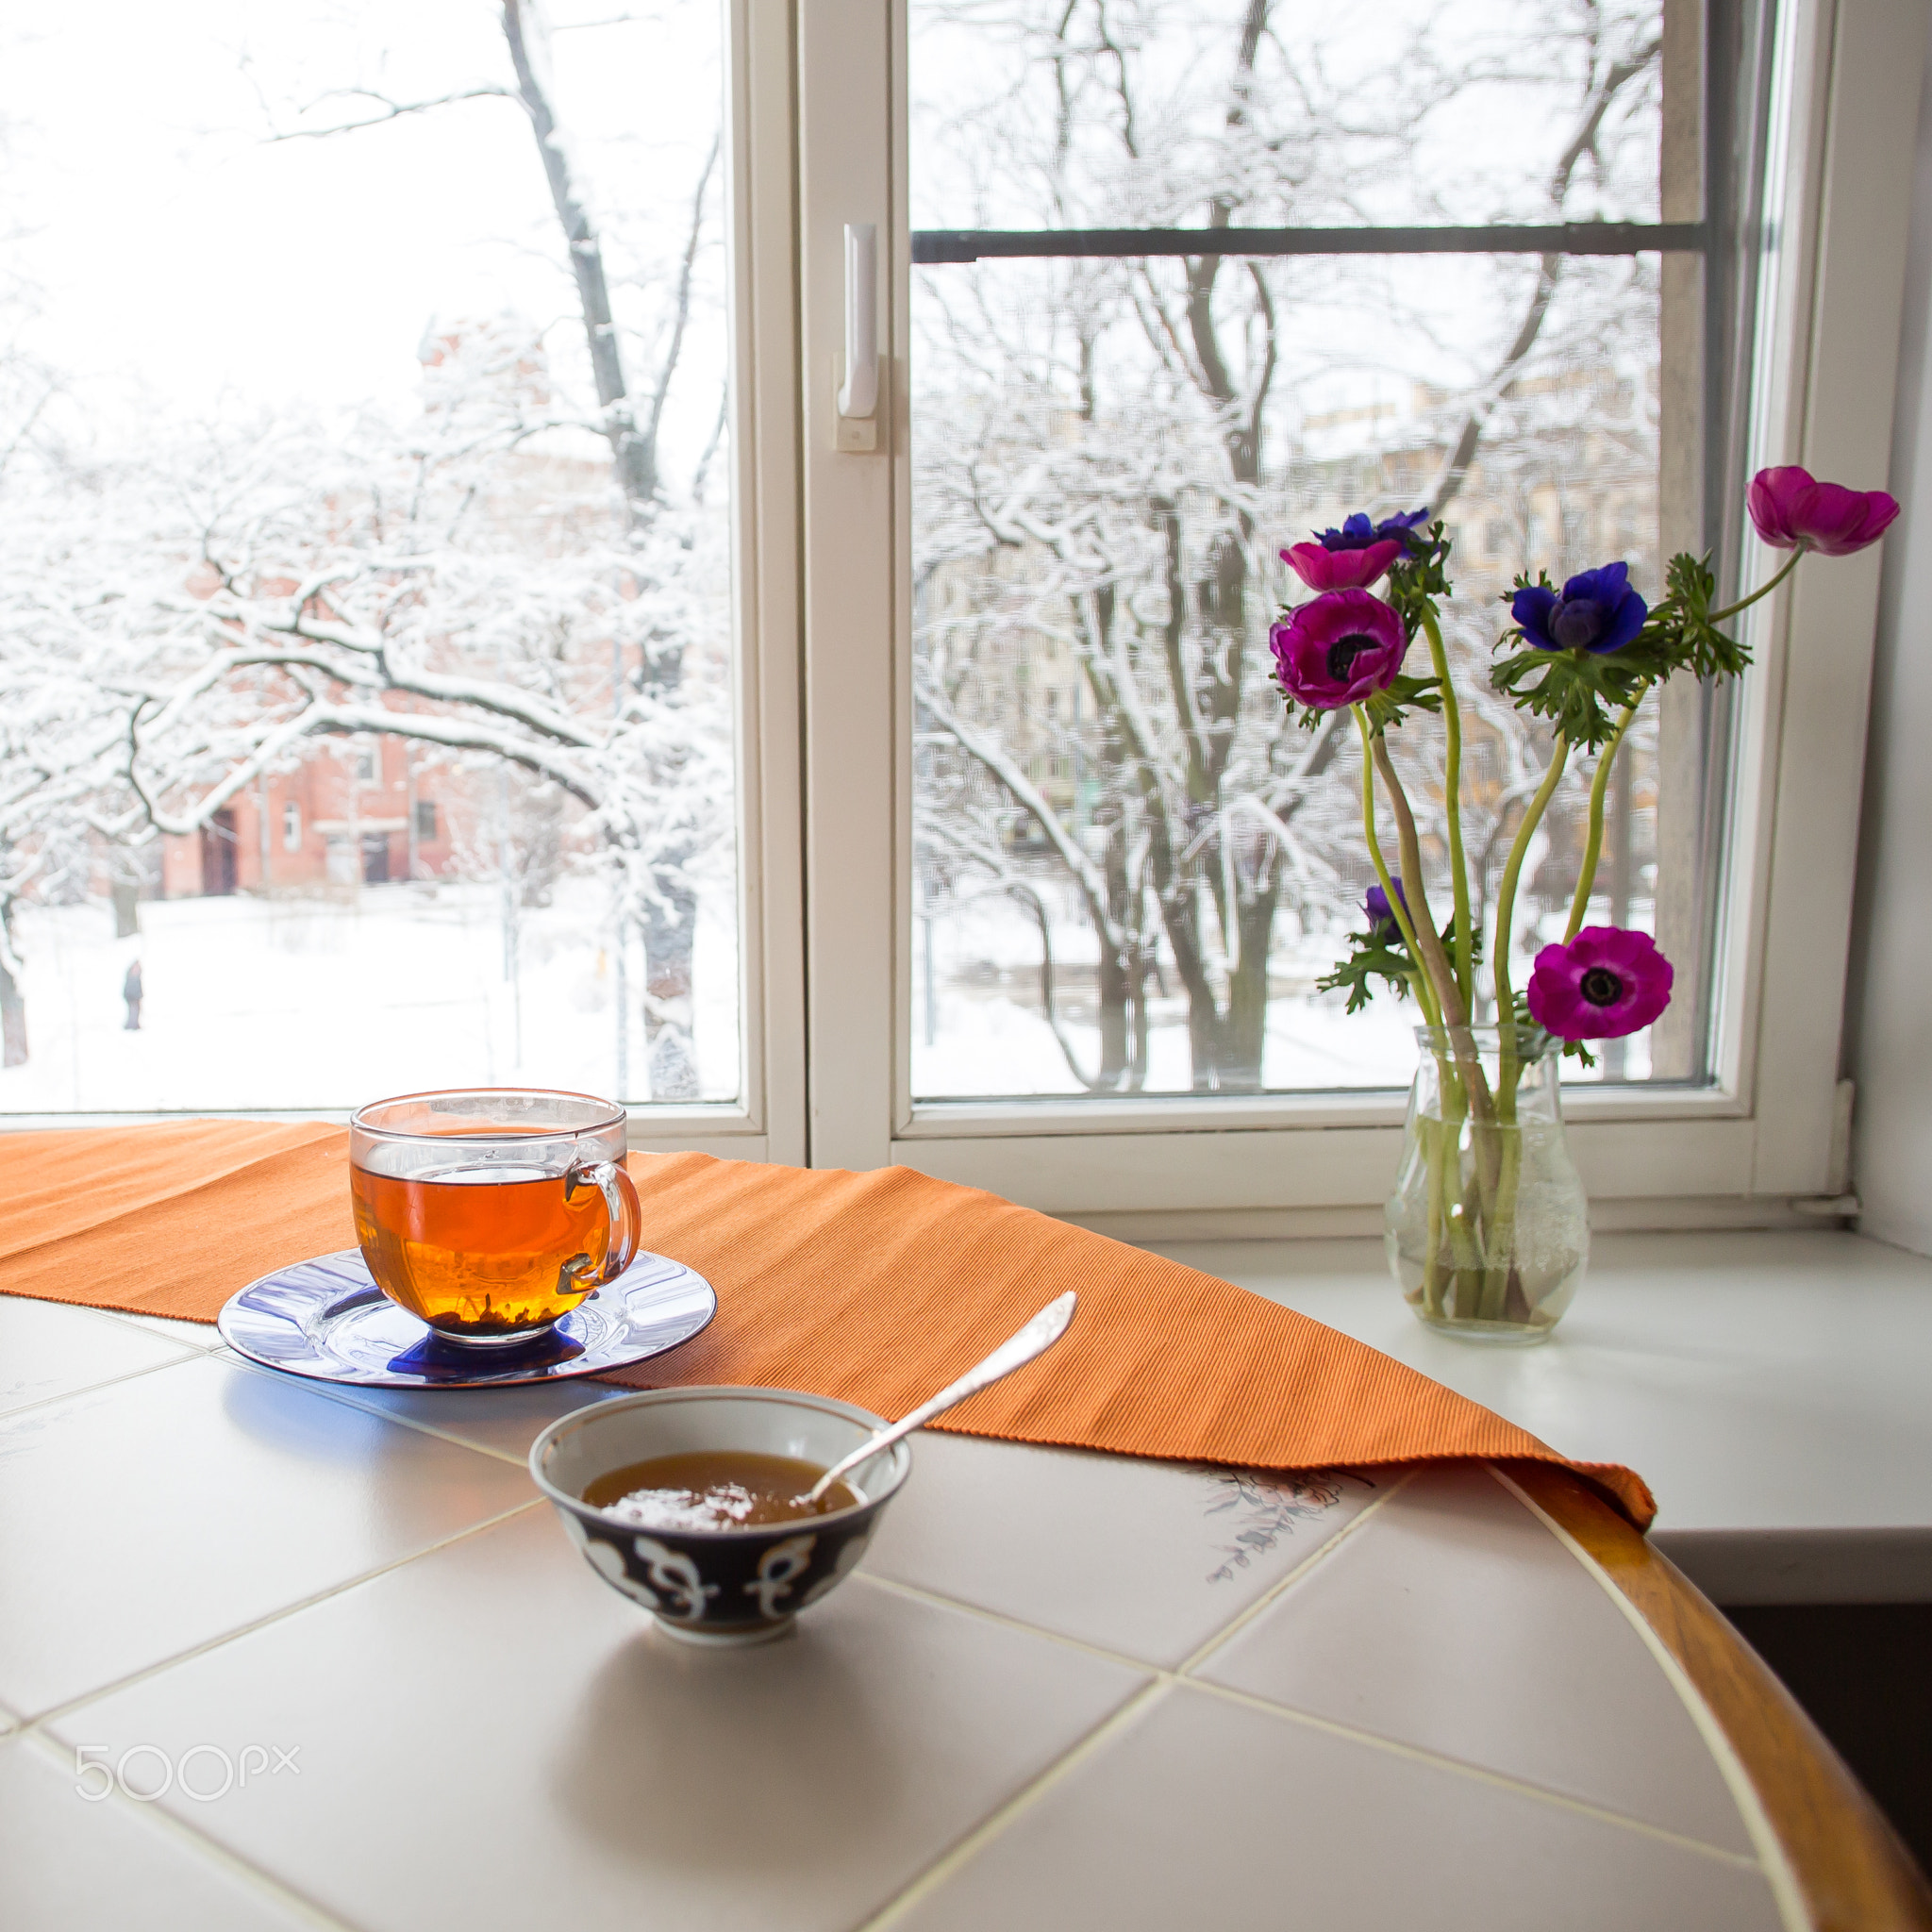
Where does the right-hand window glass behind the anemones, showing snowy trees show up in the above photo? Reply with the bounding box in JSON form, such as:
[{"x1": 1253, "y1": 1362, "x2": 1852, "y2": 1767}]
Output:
[{"x1": 912, "y1": 0, "x2": 1696, "y2": 1099}]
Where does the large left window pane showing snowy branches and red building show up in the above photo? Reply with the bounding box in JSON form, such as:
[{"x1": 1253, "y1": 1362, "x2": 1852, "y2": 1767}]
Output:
[{"x1": 0, "y1": 0, "x2": 740, "y2": 1113}]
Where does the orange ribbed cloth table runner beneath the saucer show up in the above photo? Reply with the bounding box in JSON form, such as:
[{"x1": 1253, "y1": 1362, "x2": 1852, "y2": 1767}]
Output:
[{"x1": 0, "y1": 1121, "x2": 1656, "y2": 1528}]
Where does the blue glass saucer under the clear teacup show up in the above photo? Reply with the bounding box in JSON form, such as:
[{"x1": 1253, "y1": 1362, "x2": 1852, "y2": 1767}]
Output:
[{"x1": 216, "y1": 1248, "x2": 719, "y2": 1390}]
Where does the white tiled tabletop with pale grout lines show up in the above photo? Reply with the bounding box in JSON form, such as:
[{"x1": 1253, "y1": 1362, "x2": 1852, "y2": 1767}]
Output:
[{"x1": 0, "y1": 1298, "x2": 1797, "y2": 1932}]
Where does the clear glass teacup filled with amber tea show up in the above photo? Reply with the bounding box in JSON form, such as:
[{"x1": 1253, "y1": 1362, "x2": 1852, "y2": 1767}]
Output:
[{"x1": 350, "y1": 1088, "x2": 641, "y2": 1344}]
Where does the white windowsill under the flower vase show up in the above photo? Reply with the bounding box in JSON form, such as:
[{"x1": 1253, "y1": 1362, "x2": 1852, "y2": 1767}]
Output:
[{"x1": 1148, "y1": 1233, "x2": 1932, "y2": 1604}]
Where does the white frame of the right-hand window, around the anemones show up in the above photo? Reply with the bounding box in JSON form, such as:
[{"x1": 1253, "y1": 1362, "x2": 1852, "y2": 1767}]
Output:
[{"x1": 794, "y1": 0, "x2": 1924, "y2": 1235}]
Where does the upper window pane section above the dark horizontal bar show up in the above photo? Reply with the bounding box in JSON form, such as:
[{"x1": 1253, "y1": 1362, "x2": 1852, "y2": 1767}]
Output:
[{"x1": 910, "y1": 0, "x2": 1663, "y2": 228}]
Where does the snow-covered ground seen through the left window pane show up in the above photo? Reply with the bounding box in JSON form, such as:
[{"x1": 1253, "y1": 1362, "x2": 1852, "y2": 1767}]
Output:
[{"x1": 0, "y1": 881, "x2": 738, "y2": 1113}]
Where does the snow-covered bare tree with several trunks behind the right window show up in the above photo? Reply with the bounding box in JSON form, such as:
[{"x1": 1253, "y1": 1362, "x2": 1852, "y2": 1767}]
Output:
[{"x1": 916, "y1": 0, "x2": 1656, "y2": 1091}]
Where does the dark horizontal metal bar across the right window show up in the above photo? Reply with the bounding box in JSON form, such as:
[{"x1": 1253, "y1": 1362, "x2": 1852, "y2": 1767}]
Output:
[{"x1": 912, "y1": 223, "x2": 1712, "y2": 267}]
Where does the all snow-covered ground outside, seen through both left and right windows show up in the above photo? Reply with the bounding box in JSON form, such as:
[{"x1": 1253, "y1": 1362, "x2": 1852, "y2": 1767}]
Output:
[{"x1": 0, "y1": 881, "x2": 1650, "y2": 1115}]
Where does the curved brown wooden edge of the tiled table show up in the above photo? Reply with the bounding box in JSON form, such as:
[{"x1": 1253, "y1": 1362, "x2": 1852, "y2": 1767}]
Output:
[{"x1": 1501, "y1": 1462, "x2": 1932, "y2": 1932}]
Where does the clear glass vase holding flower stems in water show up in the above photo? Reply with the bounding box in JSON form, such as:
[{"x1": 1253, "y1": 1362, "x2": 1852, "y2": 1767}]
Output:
[{"x1": 1383, "y1": 1025, "x2": 1591, "y2": 1344}]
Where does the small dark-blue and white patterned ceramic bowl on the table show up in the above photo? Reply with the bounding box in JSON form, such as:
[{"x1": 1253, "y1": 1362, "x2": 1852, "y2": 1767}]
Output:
[{"x1": 529, "y1": 1390, "x2": 912, "y2": 1644}]
